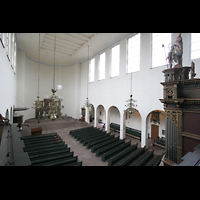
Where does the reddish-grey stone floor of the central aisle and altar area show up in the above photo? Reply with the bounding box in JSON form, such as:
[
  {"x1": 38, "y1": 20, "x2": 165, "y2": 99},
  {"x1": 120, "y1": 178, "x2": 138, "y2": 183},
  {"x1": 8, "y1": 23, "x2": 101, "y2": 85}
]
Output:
[{"x1": 21, "y1": 117, "x2": 165, "y2": 166}]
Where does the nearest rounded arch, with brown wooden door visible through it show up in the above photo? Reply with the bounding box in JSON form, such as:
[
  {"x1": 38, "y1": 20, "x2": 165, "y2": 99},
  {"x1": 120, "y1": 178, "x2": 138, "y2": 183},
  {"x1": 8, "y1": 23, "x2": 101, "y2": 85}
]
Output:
[{"x1": 146, "y1": 109, "x2": 165, "y2": 140}]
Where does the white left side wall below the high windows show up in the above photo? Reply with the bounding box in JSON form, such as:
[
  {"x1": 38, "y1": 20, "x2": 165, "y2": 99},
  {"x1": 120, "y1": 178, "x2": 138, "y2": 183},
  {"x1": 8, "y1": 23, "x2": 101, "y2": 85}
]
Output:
[{"x1": 0, "y1": 43, "x2": 17, "y2": 117}]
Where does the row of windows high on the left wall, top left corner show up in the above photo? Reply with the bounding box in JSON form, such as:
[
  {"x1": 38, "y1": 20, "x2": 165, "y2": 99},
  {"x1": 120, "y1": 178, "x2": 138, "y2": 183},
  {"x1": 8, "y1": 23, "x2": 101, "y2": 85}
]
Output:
[{"x1": 0, "y1": 33, "x2": 17, "y2": 72}]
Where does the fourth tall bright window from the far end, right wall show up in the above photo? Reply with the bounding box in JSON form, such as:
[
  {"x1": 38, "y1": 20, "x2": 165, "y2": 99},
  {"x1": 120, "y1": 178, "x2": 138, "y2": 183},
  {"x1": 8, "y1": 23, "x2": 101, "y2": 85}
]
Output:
[{"x1": 127, "y1": 33, "x2": 140, "y2": 73}]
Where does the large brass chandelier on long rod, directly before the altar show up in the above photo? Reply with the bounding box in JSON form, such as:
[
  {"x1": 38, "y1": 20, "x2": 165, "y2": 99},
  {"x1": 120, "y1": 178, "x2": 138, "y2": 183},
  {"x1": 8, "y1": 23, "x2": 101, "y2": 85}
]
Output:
[{"x1": 48, "y1": 33, "x2": 64, "y2": 121}]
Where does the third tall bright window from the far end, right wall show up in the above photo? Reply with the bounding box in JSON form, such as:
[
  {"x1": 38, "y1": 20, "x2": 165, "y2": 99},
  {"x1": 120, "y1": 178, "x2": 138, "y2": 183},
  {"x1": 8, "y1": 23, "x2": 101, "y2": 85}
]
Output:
[{"x1": 110, "y1": 44, "x2": 120, "y2": 77}]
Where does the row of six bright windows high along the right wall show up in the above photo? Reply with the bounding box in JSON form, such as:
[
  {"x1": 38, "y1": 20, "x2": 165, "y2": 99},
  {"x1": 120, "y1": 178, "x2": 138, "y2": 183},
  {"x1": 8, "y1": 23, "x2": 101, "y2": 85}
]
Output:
[{"x1": 89, "y1": 33, "x2": 200, "y2": 82}]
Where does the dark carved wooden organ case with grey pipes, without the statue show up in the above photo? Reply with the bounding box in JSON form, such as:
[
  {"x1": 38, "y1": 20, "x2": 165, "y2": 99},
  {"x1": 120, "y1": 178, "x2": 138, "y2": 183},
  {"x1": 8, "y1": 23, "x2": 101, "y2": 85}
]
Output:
[{"x1": 160, "y1": 67, "x2": 200, "y2": 164}]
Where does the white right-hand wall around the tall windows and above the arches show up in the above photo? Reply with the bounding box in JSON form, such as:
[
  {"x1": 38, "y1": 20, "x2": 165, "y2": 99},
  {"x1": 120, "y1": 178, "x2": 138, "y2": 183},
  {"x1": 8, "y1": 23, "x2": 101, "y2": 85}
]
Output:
[{"x1": 80, "y1": 33, "x2": 200, "y2": 146}]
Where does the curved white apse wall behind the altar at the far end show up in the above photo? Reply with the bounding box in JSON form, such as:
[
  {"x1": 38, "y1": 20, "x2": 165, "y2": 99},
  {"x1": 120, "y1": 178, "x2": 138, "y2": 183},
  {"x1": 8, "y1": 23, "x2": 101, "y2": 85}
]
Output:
[{"x1": 17, "y1": 51, "x2": 81, "y2": 121}]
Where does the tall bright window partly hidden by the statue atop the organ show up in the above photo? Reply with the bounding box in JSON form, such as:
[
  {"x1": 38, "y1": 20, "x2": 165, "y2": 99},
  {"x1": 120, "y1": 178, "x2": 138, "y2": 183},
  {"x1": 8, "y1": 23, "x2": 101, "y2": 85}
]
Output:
[{"x1": 152, "y1": 33, "x2": 171, "y2": 68}]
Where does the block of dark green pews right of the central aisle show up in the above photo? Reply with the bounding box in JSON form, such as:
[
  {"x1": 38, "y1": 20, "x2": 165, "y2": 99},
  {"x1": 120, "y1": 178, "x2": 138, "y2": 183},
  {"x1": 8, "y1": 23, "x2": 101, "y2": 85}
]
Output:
[{"x1": 69, "y1": 126, "x2": 162, "y2": 166}]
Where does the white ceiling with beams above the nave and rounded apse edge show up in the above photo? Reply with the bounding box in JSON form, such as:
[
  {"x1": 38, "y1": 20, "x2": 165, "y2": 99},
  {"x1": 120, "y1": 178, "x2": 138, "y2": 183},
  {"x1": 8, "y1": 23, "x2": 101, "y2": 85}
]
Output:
[{"x1": 17, "y1": 33, "x2": 129, "y2": 65}]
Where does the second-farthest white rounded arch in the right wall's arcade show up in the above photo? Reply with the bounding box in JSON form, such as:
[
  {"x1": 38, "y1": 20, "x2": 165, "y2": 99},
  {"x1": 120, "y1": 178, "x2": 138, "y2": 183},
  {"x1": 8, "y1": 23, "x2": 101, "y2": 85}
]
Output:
[{"x1": 96, "y1": 104, "x2": 106, "y2": 129}]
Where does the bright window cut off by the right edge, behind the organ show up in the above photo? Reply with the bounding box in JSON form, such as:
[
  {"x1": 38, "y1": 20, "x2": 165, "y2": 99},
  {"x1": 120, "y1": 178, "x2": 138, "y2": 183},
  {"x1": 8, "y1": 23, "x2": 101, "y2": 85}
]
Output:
[{"x1": 191, "y1": 33, "x2": 200, "y2": 59}]
